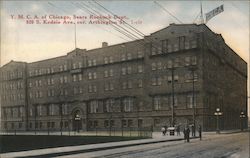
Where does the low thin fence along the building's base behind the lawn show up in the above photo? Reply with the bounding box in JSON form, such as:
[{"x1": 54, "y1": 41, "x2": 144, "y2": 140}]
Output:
[{"x1": 1, "y1": 127, "x2": 153, "y2": 138}]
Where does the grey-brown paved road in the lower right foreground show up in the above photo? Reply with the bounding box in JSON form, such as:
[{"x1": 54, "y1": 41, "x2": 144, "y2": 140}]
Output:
[{"x1": 58, "y1": 132, "x2": 250, "y2": 158}]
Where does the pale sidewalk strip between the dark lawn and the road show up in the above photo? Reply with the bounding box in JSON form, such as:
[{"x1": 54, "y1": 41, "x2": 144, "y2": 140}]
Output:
[{"x1": 0, "y1": 132, "x2": 192, "y2": 158}]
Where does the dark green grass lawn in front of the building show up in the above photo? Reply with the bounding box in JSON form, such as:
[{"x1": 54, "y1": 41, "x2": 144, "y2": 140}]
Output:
[{"x1": 0, "y1": 135, "x2": 148, "y2": 153}]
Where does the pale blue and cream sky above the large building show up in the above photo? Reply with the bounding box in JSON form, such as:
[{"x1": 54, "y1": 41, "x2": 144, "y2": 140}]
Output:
[{"x1": 0, "y1": 0, "x2": 250, "y2": 115}]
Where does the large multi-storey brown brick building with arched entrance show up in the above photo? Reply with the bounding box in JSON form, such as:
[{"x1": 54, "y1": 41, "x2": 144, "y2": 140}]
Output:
[{"x1": 0, "y1": 24, "x2": 247, "y2": 130}]
